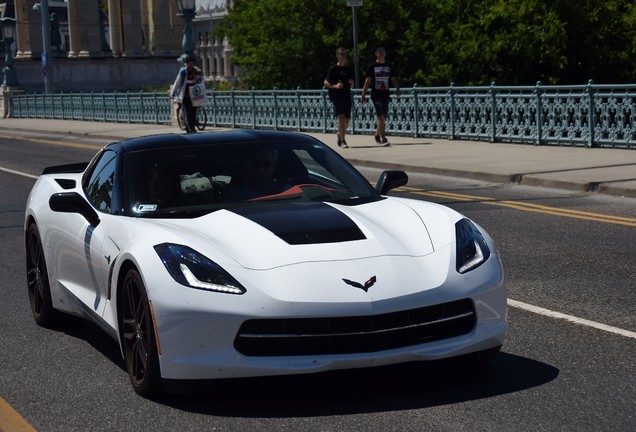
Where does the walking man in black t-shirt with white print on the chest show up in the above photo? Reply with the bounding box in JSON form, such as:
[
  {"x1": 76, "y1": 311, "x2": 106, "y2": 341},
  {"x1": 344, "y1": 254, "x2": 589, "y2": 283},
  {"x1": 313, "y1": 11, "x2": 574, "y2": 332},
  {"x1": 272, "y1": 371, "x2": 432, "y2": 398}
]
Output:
[{"x1": 360, "y1": 46, "x2": 402, "y2": 146}]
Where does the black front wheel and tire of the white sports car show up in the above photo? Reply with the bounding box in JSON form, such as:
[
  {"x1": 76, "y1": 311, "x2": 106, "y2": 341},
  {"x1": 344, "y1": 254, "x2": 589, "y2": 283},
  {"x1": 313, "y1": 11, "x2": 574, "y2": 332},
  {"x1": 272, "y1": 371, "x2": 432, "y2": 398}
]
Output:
[{"x1": 119, "y1": 269, "x2": 162, "y2": 397}]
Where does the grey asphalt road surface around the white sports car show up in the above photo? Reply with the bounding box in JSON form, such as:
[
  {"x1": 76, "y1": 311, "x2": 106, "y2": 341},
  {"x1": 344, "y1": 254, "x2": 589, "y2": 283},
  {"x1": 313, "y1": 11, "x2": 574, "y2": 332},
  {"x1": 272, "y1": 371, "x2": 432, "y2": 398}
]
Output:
[{"x1": 0, "y1": 135, "x2": 636, "y2": 432}]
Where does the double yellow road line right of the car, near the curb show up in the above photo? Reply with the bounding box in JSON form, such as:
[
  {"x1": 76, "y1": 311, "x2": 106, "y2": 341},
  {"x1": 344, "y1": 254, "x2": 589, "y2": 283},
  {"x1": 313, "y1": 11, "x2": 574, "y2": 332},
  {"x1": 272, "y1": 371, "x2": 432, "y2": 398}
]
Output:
[{"x1": 401, "y1": 187, "x2": 636, "y2": 227}]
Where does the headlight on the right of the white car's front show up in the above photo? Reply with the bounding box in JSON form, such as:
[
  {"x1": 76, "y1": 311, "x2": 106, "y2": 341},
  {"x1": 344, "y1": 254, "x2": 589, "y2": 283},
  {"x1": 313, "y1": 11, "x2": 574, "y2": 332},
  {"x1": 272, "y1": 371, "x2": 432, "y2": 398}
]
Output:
[{"x1": 455, "y1": 219, "x2": 490, "y2": 273}]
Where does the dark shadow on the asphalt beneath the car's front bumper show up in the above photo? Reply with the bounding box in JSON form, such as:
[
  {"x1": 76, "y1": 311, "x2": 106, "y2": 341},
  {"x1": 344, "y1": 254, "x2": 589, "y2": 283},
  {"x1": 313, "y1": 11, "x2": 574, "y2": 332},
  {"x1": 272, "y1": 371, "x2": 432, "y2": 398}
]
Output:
[{"x1": 156, "y1": 353, "x2": 559, "y2": 418}]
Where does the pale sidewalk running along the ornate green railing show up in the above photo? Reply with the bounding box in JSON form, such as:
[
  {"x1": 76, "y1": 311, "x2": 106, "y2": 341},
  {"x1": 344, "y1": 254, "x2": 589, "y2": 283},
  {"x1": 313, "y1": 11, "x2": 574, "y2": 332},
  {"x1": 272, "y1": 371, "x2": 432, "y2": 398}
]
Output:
[{"x1": 0, "y1": 119, "x2": 636, "y2": 198}]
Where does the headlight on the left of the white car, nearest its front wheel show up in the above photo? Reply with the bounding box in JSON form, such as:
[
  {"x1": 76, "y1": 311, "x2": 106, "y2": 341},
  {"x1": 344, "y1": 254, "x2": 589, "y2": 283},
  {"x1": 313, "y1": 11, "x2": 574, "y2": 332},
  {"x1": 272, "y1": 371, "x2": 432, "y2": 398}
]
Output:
[{"x1": 155, "y1": 243, "x2": 245, "y2": 294}]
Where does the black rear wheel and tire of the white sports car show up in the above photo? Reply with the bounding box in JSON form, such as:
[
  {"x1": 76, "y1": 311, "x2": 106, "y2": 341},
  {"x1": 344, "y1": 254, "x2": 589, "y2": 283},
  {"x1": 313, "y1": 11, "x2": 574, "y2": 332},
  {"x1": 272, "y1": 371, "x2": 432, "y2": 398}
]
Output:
[{"x1": 26, "y1": 223, "x2": 60, "y2": 327}]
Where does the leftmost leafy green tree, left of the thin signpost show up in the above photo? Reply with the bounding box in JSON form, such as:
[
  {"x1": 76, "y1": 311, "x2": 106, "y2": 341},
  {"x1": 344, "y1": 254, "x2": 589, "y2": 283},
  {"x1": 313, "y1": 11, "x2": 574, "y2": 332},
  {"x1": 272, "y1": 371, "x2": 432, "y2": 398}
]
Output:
[{"x1": 216, "y1": 0, "x2": 351, "y2": 89}]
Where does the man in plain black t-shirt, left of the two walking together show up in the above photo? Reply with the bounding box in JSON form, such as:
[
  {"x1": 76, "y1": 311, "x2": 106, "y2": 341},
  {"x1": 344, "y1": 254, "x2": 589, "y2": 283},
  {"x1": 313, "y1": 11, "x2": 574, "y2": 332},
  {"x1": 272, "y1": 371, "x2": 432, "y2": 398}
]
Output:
[{"x1": 323, "y1": 47, "x2": 354, "y2": 148}]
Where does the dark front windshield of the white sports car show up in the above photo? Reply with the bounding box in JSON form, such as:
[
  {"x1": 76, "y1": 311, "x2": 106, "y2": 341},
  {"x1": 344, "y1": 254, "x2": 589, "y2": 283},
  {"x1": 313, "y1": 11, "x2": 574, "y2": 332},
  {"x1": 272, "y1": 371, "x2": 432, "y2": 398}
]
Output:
[{"x1": 123, "y1": 138, "x2": 381, "y2": 218}]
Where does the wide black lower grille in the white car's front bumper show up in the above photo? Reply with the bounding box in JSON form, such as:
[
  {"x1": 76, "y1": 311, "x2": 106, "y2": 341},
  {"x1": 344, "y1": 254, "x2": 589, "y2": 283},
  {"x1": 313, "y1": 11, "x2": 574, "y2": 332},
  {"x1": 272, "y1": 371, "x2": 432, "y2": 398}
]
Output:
[{"x1": 234, "y1": 299, "x2": 476, "y2": 356}]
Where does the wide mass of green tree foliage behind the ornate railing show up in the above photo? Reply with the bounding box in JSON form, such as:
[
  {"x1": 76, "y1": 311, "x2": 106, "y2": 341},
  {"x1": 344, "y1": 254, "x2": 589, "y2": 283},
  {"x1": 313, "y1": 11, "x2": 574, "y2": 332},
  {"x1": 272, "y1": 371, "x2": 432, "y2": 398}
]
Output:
[{"x1": 220, "y1": 0, "x2": 636, "y2": 89}]
